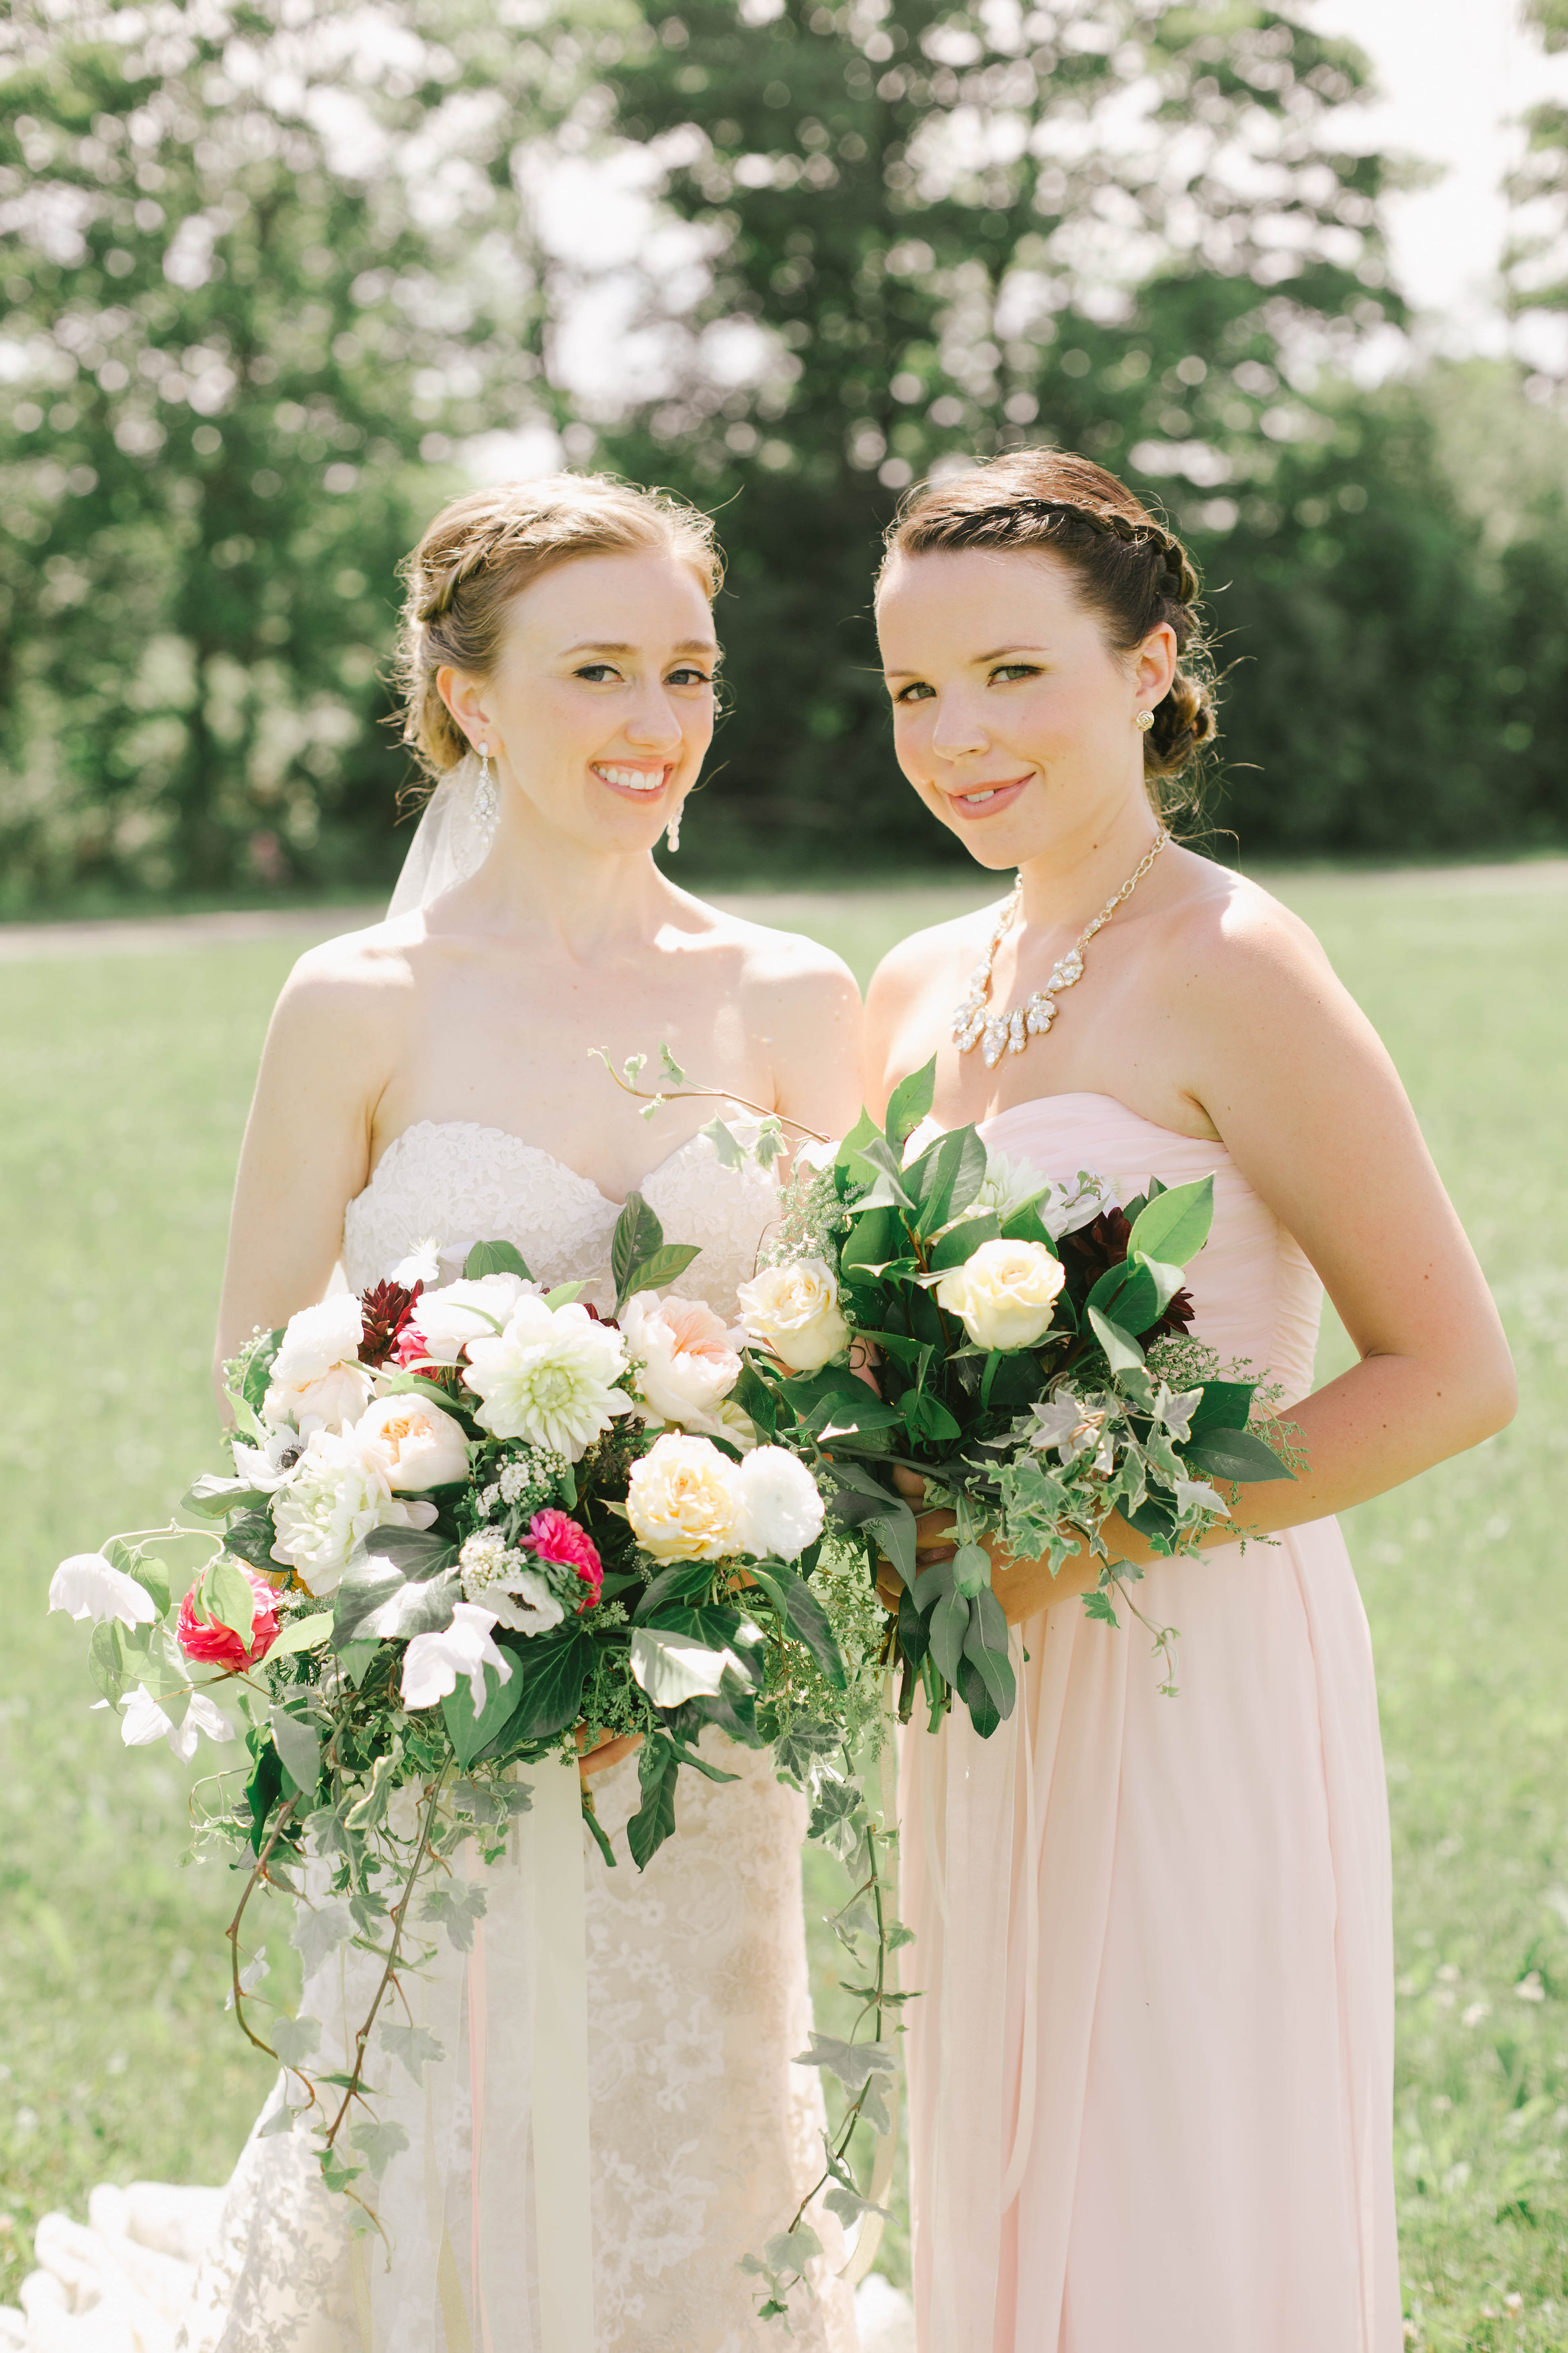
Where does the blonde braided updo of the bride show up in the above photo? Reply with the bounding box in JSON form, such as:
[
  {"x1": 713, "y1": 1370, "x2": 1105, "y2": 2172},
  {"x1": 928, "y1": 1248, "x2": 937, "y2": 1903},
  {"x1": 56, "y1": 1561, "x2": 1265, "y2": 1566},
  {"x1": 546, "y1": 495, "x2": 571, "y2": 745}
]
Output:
[{"x1": 395, "y1": 473, "x2": 724, "y2": 779}]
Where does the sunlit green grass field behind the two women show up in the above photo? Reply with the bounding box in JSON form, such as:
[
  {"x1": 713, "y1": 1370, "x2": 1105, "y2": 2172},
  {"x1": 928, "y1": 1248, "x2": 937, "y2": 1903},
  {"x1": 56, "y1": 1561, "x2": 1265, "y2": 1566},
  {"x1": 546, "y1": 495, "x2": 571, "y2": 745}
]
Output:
[{"x1": 0, "y1": 869, "x2": 1568, "y2": 2353}]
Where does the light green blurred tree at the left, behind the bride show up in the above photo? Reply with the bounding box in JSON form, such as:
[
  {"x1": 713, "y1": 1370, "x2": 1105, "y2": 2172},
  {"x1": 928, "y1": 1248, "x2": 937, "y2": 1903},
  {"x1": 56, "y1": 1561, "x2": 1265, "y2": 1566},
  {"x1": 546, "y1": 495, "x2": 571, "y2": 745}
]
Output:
[{"x1": 0, "y1": 0, "x2": 614, "y2": 908}]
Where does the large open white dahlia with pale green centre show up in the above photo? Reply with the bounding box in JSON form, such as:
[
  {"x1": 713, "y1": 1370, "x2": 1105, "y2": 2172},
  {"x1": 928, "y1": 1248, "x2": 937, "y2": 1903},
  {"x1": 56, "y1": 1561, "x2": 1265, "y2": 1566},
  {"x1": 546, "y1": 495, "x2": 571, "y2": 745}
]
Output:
[{"x1": 465, "y1": 1278, "x2": 632, "y2": 1462}]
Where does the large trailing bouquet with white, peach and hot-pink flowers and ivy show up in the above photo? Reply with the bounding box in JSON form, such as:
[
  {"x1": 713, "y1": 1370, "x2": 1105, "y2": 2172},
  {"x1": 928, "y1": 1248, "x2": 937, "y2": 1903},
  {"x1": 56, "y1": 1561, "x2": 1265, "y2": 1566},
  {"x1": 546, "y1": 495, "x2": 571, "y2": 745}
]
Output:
[{"x1": 49, "y1": 1195, "x2": 877, "y2": 2188}]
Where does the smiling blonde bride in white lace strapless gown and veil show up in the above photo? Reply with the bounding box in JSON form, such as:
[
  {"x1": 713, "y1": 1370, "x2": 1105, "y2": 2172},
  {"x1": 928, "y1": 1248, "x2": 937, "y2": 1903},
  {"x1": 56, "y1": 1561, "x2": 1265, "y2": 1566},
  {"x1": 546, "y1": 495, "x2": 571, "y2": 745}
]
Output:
[{"x1": 6, "y1": 475, "x2": 860, "y2": 2353}]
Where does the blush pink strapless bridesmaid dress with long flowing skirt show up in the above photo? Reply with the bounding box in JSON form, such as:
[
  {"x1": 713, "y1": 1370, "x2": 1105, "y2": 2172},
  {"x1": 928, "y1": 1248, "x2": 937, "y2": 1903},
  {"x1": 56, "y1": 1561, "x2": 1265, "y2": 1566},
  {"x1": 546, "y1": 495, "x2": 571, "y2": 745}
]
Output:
[{"x1": 901, "y1": 1094, "x2": 1403, "y2": 2353}]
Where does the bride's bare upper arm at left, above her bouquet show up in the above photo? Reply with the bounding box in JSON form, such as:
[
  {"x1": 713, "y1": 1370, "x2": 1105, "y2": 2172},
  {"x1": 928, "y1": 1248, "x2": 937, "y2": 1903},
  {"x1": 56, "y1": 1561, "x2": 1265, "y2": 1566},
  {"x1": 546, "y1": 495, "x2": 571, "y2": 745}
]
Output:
[{"x1": 214, "y1": 939, "x2": 395, "y2": 1377}]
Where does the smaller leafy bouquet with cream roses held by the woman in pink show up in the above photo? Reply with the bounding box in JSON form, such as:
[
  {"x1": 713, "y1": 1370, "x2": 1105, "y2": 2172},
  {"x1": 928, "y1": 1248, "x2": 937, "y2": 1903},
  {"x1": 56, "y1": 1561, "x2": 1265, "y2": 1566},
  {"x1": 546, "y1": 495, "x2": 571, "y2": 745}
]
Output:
[{"x1": 736, "y1": 1064, "x2": 1293, "y2": 1737}]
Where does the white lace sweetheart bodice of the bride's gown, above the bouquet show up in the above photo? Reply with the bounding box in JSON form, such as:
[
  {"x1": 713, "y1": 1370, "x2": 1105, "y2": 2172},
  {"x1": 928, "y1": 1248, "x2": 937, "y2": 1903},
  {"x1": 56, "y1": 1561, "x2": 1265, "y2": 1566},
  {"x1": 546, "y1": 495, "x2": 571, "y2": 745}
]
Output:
[{"x1": 343, "y1": 1120, "x2": 778, "y2": 1320}]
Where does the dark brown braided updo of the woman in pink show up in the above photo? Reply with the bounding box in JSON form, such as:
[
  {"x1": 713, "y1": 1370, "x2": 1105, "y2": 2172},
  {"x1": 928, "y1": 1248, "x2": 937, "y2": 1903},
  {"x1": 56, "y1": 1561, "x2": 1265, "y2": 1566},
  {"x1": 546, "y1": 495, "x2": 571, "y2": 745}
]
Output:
[{"x1": 884, "y1": 450, "x2": 1218, "y2": 819}]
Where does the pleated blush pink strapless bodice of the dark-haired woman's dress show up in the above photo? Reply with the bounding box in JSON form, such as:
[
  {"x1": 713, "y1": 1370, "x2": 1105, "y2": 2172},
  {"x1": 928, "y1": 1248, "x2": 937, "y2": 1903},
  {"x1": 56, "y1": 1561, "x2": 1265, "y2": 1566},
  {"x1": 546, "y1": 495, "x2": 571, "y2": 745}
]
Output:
[{"x1": 981, "y1": 1094, "x2": 1323, "y2": 1405}]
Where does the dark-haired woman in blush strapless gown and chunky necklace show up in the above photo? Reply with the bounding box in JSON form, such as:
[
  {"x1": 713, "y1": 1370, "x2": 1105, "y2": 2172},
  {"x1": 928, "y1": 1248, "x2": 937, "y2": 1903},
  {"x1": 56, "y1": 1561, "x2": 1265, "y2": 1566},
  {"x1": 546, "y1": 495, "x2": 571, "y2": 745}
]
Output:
[{"x1": 868, "y1": 450, "x2": 1514, "y2": 2353}]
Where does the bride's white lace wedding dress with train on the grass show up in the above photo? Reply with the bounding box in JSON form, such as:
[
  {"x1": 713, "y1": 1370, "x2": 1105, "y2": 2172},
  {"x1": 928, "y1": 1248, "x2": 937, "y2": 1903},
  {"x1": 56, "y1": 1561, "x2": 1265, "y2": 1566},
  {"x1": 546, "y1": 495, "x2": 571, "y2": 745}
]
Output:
[{"x1": 0, "y1": 1123, "x2": 856, "y2": 2353}]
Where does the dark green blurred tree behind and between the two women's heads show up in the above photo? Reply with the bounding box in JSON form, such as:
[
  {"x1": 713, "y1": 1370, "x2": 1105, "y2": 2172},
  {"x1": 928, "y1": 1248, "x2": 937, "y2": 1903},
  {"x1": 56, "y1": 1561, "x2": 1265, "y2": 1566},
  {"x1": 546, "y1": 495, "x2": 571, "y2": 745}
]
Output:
[{"x1": 587, "y1": 0, "x2": 1401, "y2": 861}]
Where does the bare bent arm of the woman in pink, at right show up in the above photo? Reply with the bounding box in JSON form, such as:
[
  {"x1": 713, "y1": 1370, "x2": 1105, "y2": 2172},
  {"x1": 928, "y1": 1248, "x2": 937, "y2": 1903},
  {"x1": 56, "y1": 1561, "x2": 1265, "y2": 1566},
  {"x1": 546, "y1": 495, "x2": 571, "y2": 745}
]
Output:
[{"x1": 940, "y1": 892, "x2": 1516, "y2": 1622}]
